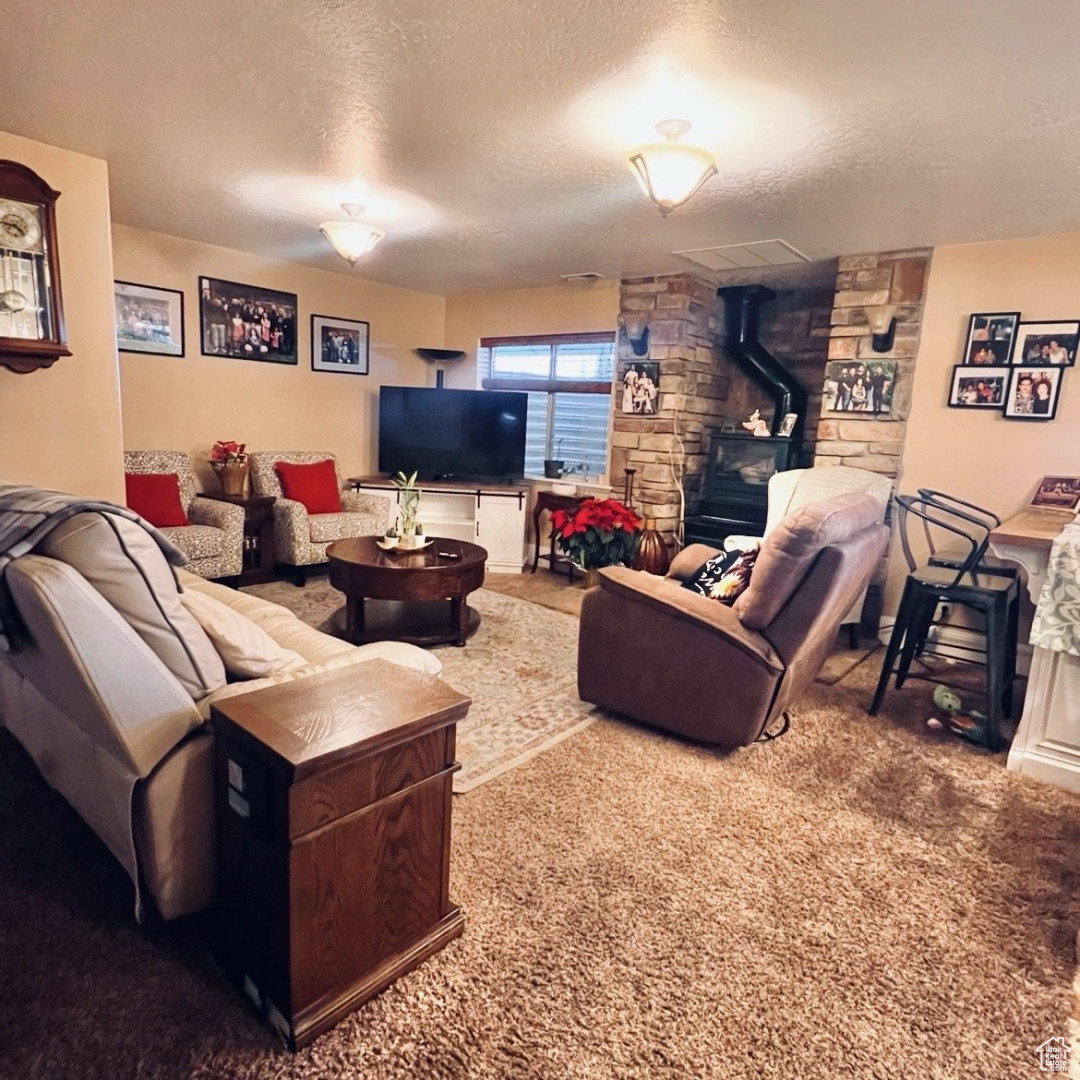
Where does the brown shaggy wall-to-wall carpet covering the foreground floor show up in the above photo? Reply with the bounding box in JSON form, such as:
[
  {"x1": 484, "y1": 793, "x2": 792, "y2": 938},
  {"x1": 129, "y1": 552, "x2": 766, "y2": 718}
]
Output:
[{"x1": 0, "y1": 648, "x2": 1080, "y2": 1080}]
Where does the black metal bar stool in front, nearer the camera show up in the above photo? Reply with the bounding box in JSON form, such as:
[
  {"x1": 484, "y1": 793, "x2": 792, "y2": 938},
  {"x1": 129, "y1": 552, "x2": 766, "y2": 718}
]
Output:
[{"x1": 868, "y1": 492, "x2": 1020, "y2": 751}]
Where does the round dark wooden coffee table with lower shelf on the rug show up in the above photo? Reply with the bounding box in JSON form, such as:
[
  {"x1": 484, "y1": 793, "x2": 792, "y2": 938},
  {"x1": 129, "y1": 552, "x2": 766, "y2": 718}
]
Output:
[{"x1": 326, "y1": 537, "x2": 487, "y2": 645}]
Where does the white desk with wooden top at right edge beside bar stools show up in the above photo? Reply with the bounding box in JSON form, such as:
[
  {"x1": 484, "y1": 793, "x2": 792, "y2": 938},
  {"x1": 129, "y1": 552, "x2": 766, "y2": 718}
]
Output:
[{"x1": 990, "y1": 510, "x2": 1080, "y2": 792}]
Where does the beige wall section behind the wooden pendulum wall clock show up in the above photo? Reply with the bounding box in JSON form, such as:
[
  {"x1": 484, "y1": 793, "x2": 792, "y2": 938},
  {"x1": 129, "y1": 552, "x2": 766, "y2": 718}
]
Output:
[{"x1": 0, "y1": 132, "x2": 123, "y2": 501}]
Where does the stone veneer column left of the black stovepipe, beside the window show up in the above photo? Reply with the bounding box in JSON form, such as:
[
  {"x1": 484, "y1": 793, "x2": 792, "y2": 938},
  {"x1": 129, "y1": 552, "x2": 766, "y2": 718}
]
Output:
[{"x1": 610, "y1": 273, "x2": 729, "y2": 539}]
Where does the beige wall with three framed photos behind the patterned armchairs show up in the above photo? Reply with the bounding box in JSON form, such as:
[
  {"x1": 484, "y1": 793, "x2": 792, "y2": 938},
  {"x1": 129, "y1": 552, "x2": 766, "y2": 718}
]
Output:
[{"x1": 112, "y1": 225, "x2": 445, "y2": 489}]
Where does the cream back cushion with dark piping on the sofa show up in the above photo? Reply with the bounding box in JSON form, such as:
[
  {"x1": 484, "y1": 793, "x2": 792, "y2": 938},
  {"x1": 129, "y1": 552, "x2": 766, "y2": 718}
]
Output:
[{"x1": 37, "y1": 513, "x2": 225, "y2": 701}]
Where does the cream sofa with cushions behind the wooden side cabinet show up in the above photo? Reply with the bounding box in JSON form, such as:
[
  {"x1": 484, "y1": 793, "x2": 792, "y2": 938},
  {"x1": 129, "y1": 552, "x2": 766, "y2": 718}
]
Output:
[{"x1": 0, "y1": 513, "x2": 442, "y2": 919}]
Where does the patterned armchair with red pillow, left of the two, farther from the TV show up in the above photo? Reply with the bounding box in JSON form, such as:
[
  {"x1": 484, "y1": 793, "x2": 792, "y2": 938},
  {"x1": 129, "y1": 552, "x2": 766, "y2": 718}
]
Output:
[{"x1": 124, "y1": 450, "x2": 244, "y2": 578}]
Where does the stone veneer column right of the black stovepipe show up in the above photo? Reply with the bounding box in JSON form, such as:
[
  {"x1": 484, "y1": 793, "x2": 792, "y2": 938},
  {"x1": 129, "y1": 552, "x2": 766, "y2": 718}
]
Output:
[{"x1": 813, "y1": 248, "x2": 931, "y2": 478}]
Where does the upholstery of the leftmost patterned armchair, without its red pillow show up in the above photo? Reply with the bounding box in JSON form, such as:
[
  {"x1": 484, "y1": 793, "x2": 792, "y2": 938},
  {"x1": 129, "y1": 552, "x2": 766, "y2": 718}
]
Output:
[{"x1": 124, "y1": 450, "x2": 244, "y2": 578}]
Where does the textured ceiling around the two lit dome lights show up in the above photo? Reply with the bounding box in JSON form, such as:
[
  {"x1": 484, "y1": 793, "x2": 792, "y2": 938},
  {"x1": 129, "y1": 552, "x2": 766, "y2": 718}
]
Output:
[{"x1": 0, "y1": 0, "x2": 1080, "y2": 294}]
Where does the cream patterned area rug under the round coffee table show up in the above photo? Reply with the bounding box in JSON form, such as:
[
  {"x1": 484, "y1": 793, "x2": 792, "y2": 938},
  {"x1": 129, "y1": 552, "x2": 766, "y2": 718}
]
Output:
[{"x1": 244, "y1": 579, "x2": 596, "y2": 794}]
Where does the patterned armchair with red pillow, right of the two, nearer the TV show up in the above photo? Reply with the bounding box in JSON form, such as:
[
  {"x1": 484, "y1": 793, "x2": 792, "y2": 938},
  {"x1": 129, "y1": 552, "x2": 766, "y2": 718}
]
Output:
[{"x1": 247, "y1": 450, "x2": 390, "y2": 584}]
